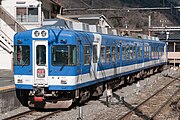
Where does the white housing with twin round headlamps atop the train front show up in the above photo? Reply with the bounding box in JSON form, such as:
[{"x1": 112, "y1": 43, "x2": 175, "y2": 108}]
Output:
[{"x1": 32, "y1": 29, "x2": 48, "y2": 38}]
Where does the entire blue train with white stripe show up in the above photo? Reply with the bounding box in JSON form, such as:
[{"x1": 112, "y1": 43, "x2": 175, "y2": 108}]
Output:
[{"x1": 14, "y1": 28, "x2": 167, "y2": 109}]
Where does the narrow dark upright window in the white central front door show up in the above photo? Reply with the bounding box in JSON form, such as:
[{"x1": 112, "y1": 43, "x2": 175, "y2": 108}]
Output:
[{"x1": 36, "y1": 45, "x2": 46, "y2": 66}]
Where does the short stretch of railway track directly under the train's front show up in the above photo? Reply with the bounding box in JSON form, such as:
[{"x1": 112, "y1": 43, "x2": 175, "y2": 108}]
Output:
[{"x1": 2, "y1": 110, "x2": 62, "y2": 120}]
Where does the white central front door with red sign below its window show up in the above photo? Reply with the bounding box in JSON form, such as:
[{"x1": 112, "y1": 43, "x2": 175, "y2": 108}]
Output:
[{"x1": 33, "y1": 41, "x2": 48, "y2": 86}]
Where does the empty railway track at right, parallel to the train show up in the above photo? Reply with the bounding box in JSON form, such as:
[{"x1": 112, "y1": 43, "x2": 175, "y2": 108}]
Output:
[{"x1": 115, "y1": 76, "x2": 180, "y2": 120}]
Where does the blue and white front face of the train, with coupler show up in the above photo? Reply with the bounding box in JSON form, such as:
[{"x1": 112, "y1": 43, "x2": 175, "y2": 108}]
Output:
[{"x1": 14, "y1": 29, "x2": 77, "y2": 108}]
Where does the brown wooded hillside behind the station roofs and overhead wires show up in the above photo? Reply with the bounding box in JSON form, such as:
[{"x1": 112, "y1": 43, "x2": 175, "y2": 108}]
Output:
[{"x1": 61, "y1": 0, "x2": 180, "y2": 32}]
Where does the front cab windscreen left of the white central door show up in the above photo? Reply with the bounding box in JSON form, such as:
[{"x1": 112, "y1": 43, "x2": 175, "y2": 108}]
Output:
[{"x1": 14, "y1": 46, "x2": 30, "y2": 66}]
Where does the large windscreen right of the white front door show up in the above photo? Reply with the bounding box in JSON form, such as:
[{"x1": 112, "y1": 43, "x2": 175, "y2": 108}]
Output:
[{"x1": 52, "y1": 45, "x2": 76, "y2": 66}]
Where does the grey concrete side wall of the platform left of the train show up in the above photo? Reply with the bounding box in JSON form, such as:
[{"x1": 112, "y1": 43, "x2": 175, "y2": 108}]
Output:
[{"x1": 0, "y1": 89, "x2": 21, "y2": 113}]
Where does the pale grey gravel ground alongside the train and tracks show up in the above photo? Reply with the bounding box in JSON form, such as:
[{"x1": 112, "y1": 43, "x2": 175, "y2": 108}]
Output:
[{"x1": 0, "y1": 69, "x2": 179, "y2": 120}]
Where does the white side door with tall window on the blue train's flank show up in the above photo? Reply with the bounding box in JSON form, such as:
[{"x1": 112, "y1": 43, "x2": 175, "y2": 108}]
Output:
[{"x1": 90, "y1": 34, "x2": 102, "y2": 79}]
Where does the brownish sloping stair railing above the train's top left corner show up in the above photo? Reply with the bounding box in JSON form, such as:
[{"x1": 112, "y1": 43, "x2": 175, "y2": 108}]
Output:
[{"x1": 0, "y1": 5, "x2": 26, "y2": 32}]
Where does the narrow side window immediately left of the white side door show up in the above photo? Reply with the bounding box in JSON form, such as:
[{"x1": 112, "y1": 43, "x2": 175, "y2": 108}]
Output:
[{"x1": 84, "y1": 45, "x2": 90, "y2": 65}]
